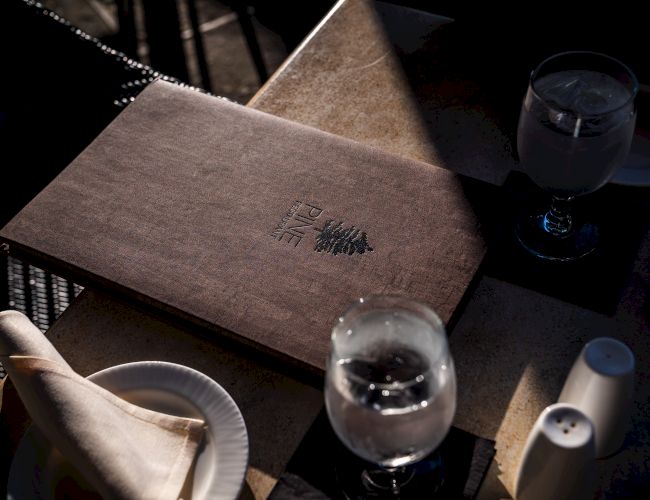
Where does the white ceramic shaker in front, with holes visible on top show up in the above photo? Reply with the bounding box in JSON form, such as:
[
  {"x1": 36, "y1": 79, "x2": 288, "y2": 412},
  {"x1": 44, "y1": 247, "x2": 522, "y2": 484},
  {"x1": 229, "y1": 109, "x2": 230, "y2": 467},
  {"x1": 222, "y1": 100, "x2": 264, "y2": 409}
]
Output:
[{"x1": 515, "y1": 403, "x2": 596, "y2": 500}]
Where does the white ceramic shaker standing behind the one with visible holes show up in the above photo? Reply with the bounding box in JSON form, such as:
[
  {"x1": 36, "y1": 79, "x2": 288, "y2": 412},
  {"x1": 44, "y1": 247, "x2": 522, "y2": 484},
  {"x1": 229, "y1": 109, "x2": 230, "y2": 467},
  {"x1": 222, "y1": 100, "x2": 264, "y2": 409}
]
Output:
[{"x1": 559, "y1": 337, "x2": 635, "y2": 458}]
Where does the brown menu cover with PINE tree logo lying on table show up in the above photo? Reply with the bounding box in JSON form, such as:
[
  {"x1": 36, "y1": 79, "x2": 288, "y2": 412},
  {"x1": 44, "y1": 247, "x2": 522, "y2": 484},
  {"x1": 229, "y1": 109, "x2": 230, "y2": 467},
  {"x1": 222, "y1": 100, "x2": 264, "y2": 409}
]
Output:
[{"x1": 0, "y1": 81, "x2": 485, "y2": 369}]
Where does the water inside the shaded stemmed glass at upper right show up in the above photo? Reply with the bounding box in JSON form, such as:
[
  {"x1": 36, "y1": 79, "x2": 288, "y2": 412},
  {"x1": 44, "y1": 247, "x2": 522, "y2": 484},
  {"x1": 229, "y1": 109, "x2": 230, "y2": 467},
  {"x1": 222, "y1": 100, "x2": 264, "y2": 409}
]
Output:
[{"x1": 517, "y1": 70, "x2": 635, "y2": 198}]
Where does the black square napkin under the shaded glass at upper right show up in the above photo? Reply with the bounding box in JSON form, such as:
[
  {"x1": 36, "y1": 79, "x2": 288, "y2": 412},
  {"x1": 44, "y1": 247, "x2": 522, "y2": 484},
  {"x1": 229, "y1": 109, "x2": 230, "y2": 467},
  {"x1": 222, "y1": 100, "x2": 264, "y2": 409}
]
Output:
[{"x1": 462, "y1": 172, "x2": 650, "y2": 316}]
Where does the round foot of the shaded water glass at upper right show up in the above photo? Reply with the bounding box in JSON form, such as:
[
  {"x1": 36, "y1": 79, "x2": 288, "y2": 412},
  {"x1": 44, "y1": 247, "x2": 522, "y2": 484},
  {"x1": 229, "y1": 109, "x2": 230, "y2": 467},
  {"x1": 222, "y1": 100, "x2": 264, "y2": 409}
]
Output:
[{"x1": 516, "y1": 214, "x2": 599, "y2": 262}]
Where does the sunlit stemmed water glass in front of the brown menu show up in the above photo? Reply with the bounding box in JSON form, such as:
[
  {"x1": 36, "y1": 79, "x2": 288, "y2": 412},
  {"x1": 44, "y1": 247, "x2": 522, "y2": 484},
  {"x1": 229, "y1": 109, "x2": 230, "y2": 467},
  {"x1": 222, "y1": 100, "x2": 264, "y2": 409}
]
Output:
[{"x1": 325, "y1": 296, "x2": 456, "y2": 498}]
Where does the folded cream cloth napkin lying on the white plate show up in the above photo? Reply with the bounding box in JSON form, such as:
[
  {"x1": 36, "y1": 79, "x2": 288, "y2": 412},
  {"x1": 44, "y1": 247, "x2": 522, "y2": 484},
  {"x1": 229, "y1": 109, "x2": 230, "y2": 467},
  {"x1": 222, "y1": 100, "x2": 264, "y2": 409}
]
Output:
[{"x1": 0, "y1": 311, "x2": 204, "y2": 500}]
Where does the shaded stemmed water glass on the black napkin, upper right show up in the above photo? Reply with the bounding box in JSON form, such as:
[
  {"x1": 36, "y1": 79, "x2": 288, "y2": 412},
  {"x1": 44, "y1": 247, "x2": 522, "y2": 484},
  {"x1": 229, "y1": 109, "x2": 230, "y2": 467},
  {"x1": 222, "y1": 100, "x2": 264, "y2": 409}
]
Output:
[{"x1": 516, "y1": 52, "x2": 638, "y2": 261}]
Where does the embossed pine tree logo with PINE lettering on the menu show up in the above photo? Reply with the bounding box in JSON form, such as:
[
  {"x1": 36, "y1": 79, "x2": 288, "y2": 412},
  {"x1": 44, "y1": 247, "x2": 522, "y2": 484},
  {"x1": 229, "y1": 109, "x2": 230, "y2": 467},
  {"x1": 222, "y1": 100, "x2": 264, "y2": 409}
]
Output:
[{"x1": 271, "y1": 201, "x2": 373, "y2": 255}]
